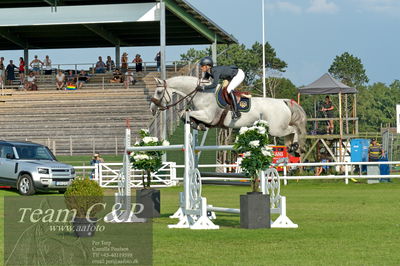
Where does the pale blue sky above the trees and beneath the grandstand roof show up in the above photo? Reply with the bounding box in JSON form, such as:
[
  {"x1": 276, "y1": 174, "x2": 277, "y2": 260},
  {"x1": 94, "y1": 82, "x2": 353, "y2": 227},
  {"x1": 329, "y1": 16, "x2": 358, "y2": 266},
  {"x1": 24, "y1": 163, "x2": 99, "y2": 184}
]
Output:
[{"x1": 0, "y1": 0, "x2": 400, "y2": 86}]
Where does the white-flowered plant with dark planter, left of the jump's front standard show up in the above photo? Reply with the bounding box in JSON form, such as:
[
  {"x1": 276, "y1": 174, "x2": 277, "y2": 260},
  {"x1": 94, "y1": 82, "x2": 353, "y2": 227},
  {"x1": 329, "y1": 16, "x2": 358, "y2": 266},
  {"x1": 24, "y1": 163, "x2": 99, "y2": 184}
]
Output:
[{"x1": 130, "y1": 129, "x2": 169, "y2": 218}]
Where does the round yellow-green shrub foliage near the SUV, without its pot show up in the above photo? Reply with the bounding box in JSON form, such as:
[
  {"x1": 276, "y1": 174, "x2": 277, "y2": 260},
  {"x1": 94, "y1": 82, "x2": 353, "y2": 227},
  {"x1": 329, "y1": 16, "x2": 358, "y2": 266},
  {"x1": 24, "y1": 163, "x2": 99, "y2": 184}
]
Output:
[{"x1": 64, "y1": 178, "x2": 104, "y2": 217}]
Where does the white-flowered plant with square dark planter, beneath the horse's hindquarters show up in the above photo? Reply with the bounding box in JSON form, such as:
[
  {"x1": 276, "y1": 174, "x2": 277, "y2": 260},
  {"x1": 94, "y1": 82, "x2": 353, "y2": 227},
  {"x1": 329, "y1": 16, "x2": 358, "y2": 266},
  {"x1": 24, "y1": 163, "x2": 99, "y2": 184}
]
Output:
[{"x1": 234, "y1": 120, "x2": 273, "y2": 228}]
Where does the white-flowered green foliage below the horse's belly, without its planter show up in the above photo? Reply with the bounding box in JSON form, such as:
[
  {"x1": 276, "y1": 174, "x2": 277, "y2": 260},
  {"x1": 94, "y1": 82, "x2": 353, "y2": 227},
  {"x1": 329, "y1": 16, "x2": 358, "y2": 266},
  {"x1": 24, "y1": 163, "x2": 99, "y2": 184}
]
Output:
[{"x1": 233, "y1": 120, "x2": 274, "y2": 192}]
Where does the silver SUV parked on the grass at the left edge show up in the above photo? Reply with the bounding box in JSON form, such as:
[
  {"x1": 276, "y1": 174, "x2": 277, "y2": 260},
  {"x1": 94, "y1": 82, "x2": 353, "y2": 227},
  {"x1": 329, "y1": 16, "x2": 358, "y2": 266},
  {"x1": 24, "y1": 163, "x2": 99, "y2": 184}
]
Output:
[{"x1": 0, "y1": 140, "x2": 75, "y2": 195}]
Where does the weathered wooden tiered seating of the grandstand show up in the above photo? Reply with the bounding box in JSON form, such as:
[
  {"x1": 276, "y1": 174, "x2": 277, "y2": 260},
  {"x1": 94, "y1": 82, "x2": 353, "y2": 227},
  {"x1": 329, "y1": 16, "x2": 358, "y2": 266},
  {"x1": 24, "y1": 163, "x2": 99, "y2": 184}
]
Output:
[{"x1": 0, "y1": 67, "x2": 179, "y2": 155}]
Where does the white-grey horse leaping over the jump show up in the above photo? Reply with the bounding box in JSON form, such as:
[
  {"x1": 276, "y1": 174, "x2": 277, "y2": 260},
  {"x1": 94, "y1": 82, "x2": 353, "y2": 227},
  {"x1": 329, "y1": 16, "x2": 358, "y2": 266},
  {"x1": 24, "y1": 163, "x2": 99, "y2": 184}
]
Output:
[{"x1": 150, "y1": 76, "x2": 306, "y2": 151}]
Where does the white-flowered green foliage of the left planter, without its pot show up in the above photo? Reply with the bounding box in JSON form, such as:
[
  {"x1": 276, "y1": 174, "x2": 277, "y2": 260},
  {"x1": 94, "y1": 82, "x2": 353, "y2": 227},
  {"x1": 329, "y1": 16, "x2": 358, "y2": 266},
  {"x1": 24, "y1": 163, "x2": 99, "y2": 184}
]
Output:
[{"x1": 130, "y1": 129, "x2": 169, "y2": 189}]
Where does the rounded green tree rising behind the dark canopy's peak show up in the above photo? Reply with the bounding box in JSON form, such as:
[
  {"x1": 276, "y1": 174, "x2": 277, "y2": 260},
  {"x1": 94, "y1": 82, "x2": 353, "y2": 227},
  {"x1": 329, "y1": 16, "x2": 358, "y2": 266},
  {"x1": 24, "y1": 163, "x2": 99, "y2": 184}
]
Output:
[{"x1": 328, "y1": 52, "x2": 369, "y2": 88}]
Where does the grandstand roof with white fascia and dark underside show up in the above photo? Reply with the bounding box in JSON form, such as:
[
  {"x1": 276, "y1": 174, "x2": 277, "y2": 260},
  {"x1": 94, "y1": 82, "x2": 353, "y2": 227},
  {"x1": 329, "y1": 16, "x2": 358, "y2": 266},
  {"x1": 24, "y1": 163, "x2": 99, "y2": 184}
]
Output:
[{"x1": 0, "y1": 0, "x2": 237, "y2": 50}]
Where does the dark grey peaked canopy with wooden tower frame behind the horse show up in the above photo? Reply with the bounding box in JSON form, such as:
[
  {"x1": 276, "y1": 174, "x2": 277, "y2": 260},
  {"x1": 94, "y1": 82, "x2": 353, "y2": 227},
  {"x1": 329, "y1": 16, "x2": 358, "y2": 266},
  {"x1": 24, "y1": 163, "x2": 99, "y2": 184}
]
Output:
[{"x1": 297, "y1": 73, "x2": 358, "y2": 161}]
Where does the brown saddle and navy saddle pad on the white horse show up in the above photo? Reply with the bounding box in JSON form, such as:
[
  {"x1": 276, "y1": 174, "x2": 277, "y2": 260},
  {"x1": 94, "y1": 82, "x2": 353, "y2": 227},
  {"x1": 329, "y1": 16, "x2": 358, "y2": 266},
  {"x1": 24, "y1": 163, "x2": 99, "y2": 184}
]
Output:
[{"x1": 216, "y1": 80, "x2": 251, "y2": 112}]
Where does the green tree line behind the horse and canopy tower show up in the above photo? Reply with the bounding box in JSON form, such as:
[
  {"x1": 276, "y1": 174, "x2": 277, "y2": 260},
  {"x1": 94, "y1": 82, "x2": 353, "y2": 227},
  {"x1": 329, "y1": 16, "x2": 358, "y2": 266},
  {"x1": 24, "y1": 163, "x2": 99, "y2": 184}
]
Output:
[{"x1": 181, "y1": 45, "x2": 400, "y2": 132}]
